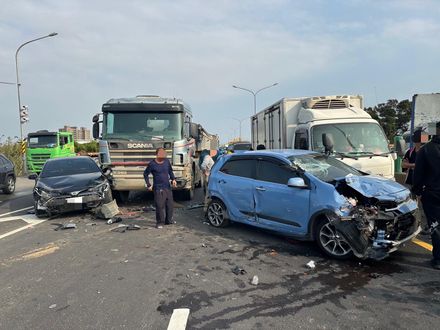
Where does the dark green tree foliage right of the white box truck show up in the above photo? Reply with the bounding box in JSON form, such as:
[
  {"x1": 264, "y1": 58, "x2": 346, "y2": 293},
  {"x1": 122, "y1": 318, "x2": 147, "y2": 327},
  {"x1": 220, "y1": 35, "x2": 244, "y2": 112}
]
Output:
[{"x1": 365, "y1": 99, "x2": 411, "y2": 141}]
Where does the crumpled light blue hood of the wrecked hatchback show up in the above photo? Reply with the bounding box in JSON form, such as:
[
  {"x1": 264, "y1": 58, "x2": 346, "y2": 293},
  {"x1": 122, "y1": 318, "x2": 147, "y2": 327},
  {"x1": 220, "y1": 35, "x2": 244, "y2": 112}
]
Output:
[{"x1": 341, "y1": 175, "x2": 411, "y2": 202}]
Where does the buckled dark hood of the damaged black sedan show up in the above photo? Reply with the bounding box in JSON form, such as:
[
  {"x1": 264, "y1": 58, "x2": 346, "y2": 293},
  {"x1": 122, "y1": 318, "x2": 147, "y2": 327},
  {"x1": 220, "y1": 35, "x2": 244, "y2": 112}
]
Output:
[{"x1": 36, "y1": 172, "x2": 105, "y2": 194}]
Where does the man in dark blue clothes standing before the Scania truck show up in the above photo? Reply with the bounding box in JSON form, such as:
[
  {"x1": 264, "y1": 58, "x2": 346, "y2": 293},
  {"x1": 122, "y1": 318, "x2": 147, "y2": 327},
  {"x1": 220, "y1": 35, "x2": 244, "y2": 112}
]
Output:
[{"x1": 144, "y1": 148, "x2": 177, "y2": 229}]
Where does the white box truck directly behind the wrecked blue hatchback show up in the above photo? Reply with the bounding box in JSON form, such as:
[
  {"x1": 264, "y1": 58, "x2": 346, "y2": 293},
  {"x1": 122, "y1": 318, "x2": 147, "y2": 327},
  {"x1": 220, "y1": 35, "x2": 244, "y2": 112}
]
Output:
[{"x1": 251, "y1": 95, "x2": 396, "y2": 179}]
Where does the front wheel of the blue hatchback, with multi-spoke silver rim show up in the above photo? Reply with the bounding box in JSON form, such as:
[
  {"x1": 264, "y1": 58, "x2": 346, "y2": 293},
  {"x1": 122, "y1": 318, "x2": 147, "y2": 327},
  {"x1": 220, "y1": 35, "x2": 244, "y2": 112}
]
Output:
[{"x1": 314, "y1": 217, "x2": 353, "y2": 260}]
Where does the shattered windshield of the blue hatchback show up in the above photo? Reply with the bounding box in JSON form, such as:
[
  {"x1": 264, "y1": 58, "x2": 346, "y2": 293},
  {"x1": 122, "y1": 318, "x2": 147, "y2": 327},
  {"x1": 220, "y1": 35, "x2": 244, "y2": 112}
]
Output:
[{"x1": 289, "y1": 154, "x2": 362, "y2": 182}]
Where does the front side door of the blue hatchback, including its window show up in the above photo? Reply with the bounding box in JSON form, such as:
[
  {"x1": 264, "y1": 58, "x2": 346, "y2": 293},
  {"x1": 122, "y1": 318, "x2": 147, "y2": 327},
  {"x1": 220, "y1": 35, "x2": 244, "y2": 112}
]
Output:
[{"x1": 255, "y1": 158, "x2": 310, "y2": 235}]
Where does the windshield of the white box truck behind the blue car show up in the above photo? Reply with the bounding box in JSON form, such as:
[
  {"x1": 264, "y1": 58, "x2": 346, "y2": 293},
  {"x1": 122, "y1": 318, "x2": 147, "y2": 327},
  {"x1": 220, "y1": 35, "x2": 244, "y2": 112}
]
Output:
[{"x1": 312, "y1": 123, "x2": 390, "y2": 156}]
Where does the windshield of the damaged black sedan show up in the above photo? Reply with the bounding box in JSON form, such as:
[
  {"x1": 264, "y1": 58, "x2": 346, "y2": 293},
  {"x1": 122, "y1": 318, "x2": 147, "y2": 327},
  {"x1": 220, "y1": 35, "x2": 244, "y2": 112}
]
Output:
[{"x1": 40, "y1": 157, "x2": 101, "y2": 178}]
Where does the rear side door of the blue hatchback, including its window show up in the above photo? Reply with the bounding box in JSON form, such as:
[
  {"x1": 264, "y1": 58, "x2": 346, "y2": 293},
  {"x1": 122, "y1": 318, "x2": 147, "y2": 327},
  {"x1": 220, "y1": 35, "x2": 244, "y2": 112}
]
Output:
[{"x1": 217, "y1": 157, "x2": 256, "y2": 222}]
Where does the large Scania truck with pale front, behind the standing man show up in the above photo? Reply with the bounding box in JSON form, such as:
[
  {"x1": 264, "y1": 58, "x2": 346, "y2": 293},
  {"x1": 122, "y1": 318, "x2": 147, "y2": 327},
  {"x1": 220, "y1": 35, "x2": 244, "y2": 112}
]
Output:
[{"x1": 93, "y1": 95, "x2": 218, "y2": 201}]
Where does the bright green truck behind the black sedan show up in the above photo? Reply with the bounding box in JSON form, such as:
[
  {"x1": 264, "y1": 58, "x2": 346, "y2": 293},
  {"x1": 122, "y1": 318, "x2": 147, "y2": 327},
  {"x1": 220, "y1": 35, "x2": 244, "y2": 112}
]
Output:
[{"x1": 26, "y1": 130, "x2": 76, "y2": 174}]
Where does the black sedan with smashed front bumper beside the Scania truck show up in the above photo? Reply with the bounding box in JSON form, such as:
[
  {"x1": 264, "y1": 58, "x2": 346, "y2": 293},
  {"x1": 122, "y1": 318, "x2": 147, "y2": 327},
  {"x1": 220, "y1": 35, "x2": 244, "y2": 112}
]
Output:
[{"x1": 29, "y1": 157, "x2": 112, "y2": 217}]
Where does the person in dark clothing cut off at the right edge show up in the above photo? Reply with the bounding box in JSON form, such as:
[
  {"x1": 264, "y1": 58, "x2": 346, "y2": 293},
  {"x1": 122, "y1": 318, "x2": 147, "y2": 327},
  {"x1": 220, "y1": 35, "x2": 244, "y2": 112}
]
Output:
[{"x1": 413, "y1": 122, "x2": 440, "y2": 270}]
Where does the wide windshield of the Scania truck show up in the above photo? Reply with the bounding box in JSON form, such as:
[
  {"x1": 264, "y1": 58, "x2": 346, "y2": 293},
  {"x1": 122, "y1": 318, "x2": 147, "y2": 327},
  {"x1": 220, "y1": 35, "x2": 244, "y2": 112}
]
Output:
[{"x1": 103, "y1": 112, "x2": 183, "y2": 141}]
